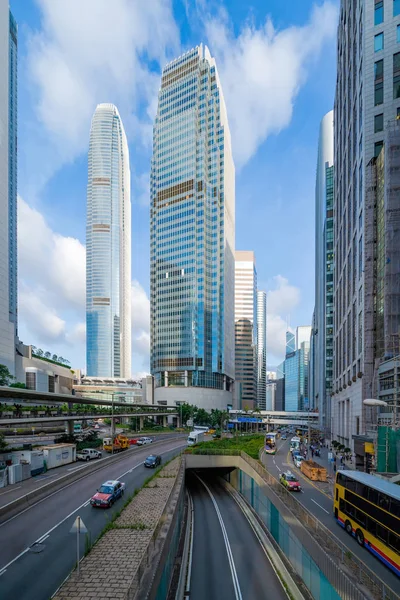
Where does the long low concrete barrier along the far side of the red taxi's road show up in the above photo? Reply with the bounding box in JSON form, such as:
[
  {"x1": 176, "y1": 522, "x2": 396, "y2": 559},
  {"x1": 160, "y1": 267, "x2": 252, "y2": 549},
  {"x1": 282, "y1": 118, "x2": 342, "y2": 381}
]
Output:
[{"x1": 0, "y1": 436, "x2": 182, "y2": 524}]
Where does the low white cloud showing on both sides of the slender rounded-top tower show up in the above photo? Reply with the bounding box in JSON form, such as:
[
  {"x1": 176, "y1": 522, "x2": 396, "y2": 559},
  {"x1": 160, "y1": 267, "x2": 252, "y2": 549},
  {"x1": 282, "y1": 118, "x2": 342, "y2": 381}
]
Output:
[{"x1": 18, "y1": 198, "x2": 150, "y2": 372}]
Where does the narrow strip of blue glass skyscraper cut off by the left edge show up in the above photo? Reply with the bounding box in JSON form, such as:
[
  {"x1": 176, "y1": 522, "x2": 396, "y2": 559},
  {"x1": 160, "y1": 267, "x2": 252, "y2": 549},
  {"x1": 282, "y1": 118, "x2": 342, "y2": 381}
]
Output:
[{"x1": 0, "y1": 7, "x2": 18, "y2": 374}]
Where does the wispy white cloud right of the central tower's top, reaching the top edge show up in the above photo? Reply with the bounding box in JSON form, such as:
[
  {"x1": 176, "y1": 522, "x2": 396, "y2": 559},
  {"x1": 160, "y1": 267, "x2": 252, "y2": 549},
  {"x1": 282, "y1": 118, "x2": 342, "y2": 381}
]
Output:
[{"x1": 201, "y1": 1, "x2": 337, "y2": 166}]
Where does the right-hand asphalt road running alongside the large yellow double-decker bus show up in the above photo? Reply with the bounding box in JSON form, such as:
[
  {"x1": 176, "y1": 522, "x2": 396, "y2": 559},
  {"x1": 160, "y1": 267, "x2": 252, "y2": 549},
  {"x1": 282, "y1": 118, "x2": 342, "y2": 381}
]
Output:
[{"x1": 263, "y1": 436, "x2": 400, "y2": 594}]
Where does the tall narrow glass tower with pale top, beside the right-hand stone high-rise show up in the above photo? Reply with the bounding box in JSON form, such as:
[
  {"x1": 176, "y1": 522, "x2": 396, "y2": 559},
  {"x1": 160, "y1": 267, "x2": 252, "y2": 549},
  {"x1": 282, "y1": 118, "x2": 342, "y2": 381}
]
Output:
[{"x1": 309, "y1": 111, "x2": 334, "y2": 439}]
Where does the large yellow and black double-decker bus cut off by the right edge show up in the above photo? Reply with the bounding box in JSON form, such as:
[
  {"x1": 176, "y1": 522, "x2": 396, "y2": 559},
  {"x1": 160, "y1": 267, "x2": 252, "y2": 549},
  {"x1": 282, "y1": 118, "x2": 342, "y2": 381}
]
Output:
[{"x1": 333, "y1": 471, "x2": 400, "y2": 576}]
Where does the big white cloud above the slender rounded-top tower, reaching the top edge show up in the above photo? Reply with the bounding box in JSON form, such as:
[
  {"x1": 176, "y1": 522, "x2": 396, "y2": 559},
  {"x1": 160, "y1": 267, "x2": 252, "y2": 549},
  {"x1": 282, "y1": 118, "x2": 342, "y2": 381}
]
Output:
[{"x1": 26, "y1": 0, "x2": 179, "y2": 184}]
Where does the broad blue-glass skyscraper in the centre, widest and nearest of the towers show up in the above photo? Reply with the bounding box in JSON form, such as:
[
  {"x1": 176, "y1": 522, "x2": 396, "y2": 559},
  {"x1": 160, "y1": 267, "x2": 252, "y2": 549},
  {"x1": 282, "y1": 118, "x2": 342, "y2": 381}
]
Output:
[{"x1": 150, "y1": 45, "x2": 235, "y2": 408}]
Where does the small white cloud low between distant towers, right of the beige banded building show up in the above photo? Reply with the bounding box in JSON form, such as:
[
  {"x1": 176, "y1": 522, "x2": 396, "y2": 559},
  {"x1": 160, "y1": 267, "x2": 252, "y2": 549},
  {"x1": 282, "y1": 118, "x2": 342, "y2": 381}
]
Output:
[{"x1": 267, "y1": 275, "x2": 300, "y2": 365}]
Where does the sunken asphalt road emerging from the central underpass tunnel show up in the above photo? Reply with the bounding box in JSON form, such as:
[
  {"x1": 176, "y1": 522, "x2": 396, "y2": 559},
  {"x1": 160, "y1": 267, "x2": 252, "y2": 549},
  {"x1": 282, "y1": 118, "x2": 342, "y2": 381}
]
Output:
[{"x1": 186, "y1": 472, "x2": 287, "y2": 600}]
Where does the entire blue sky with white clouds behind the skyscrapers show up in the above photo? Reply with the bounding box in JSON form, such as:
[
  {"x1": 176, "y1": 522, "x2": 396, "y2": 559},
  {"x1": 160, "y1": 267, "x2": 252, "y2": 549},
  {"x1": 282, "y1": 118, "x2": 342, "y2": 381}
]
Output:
[{"x1": 10, "y1": 0, "x2": 339, "y2": 375}]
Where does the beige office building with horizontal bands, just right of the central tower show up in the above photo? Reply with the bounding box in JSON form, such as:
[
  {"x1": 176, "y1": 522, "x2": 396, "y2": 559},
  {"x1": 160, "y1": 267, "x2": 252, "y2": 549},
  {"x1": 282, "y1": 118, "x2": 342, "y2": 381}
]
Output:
[{"x1": 235, "y1": 250, "x2": 258, "y2": 408}]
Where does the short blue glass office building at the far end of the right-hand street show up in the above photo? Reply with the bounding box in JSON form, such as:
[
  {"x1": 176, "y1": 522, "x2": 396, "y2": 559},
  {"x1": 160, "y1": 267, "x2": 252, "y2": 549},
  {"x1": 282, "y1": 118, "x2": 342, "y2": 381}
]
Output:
[{"x1": 277, "y1": 326, "x2": 311, "y2": 412}]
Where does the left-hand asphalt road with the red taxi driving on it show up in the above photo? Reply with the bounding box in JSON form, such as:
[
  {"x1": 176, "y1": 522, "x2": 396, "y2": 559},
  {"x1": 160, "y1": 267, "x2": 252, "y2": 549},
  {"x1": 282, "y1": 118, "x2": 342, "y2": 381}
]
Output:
[{"x1": 0, "y1": 438, "x2": 186, "y2": 600}]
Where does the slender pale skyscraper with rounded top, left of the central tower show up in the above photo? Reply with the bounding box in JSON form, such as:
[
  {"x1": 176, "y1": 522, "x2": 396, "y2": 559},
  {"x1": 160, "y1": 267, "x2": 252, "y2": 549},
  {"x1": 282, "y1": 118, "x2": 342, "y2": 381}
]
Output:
[{"x1": 86, "y1": 104, "x2": 131, "y2": 377}]
